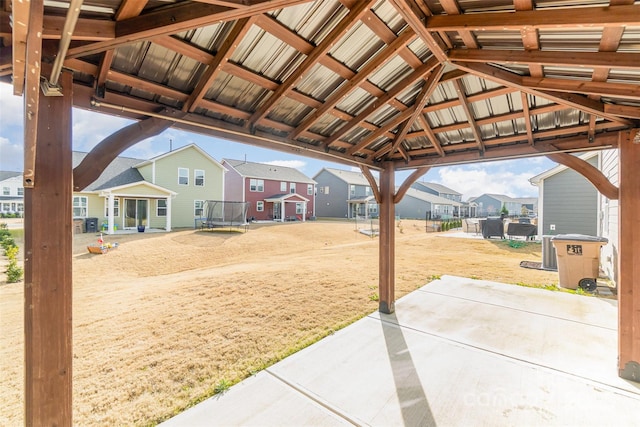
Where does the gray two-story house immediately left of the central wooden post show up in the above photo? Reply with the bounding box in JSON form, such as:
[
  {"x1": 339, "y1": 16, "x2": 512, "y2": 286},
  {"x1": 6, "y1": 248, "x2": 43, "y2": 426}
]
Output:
[{"x1": 313, "y1": 168, "x2": 378, "y2": 218}]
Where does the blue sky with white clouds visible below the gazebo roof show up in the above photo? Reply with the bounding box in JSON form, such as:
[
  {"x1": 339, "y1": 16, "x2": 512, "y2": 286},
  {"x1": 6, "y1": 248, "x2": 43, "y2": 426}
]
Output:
[{"x1": 0, "y1": 83, "x2": 556, "y2": 201}]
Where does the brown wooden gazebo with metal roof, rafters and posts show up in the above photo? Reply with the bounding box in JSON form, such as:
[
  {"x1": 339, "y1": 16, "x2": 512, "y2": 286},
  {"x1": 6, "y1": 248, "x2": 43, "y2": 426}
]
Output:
[{"x1": 0, "y1": 0, "x2": 640, "y2": 426}]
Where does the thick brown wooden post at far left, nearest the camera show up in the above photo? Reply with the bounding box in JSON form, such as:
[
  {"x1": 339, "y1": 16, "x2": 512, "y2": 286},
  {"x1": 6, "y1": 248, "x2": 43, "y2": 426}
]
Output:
[{"x1": 24, "y1": 71, "x2": 73, "y2": 427}]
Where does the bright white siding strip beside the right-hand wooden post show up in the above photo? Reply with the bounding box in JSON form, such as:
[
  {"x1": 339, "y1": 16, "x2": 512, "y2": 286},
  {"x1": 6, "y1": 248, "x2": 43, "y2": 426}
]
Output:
[{"x1": 599, "y1": 149, "x2": 620, "y2": 283}]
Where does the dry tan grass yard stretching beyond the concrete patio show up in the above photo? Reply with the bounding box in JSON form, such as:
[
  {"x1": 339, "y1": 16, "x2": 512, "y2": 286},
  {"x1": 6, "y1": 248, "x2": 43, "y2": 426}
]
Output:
[{"x1": 0, "y1": 221, "x2": 557, "y2": 426}]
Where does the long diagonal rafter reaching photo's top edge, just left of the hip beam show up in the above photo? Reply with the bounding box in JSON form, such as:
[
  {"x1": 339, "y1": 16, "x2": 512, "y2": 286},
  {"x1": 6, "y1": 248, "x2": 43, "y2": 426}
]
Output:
[{"x1": 248, "y1": 0, "x2": 373, "y2": 126}]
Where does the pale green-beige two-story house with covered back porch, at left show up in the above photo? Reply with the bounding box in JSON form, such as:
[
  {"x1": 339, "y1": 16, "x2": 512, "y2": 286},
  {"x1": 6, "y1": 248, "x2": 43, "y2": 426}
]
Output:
[{"x1": 73, "y1": 144, "x2": 226, "y2": 234}]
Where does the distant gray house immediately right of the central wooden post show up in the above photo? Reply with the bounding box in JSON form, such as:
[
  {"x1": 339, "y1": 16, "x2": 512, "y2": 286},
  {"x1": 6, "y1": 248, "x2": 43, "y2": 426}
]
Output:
[{"x1": 396, "y1": 188, "x2": 462, "y2": 219}]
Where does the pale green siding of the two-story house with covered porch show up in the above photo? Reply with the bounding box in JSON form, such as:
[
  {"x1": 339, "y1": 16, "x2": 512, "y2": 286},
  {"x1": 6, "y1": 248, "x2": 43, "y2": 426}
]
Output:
[{"x1": 138, "y1": 147, "x2": 224, "y2": 228}]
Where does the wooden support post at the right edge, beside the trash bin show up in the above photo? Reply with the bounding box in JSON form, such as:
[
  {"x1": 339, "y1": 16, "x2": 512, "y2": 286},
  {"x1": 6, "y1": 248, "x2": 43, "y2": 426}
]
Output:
[{"x1": 618, "y1": 129, "x2": 640, "y2": 382}]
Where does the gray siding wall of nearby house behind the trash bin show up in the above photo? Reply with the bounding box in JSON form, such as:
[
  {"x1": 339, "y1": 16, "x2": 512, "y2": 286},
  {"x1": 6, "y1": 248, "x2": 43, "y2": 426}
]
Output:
[{"x1": 542, "y1": 156, "x2": 598, "y2": 236}]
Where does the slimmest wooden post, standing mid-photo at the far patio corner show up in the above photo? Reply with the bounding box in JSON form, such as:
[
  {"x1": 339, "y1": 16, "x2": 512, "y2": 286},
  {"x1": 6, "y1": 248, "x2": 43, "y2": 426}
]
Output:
[{"x1": 378, "y1": 162, "x2": 396, "y2": 314}]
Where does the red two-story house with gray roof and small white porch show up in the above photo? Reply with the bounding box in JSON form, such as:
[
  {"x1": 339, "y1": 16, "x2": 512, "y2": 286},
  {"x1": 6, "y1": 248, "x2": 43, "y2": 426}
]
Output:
[{"x1": 222, "y1": 159, "x2": 316, "y2": 221}]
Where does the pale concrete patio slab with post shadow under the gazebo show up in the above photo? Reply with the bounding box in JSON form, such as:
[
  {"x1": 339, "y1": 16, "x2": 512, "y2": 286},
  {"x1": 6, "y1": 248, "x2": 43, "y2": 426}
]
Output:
[{"x1": 162, "y1": 276, "x2": 640, "y2": 427}]
